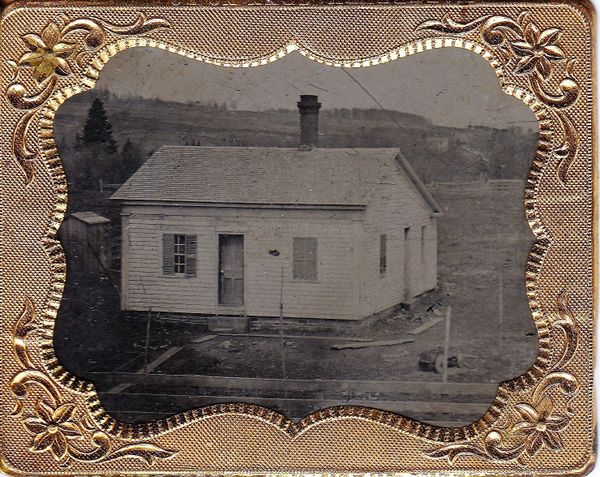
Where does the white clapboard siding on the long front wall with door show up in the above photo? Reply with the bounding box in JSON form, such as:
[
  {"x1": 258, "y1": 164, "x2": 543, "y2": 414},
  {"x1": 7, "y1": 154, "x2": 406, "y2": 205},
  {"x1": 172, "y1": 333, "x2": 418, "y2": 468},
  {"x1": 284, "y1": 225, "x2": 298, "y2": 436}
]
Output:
[{"x1": 123, "y1": 207, "x2": 360, "y2": 319}]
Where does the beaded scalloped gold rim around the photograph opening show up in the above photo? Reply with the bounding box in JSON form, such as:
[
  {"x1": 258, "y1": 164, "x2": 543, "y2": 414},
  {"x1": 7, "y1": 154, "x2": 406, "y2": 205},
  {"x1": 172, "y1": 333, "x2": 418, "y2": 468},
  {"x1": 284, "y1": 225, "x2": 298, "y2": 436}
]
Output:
[{"x1": 40, "y1": 37, "x2": 551, "y2": 442}]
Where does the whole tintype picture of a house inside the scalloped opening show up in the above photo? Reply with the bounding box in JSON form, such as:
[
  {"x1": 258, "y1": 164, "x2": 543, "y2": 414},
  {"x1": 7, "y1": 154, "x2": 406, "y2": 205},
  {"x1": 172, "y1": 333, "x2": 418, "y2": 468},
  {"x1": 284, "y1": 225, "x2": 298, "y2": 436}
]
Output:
[{"x1": 54, "y1": 48, "x2": 538, "y2": 427}]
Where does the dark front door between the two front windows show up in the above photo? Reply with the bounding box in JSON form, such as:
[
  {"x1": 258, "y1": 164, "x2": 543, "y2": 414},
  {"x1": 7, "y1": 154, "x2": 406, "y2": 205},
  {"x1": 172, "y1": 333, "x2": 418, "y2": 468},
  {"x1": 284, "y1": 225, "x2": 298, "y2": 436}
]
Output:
[{"x1": 219, "y1": 235, "x2": 244, "y2": 306}]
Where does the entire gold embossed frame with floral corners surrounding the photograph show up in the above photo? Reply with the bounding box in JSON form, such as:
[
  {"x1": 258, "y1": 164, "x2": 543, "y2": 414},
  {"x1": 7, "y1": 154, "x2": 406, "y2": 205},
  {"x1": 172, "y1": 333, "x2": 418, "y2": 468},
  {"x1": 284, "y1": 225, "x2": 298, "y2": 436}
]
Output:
[{"x1": 0, "y1": 0, "x2": 595, "y2": 475}]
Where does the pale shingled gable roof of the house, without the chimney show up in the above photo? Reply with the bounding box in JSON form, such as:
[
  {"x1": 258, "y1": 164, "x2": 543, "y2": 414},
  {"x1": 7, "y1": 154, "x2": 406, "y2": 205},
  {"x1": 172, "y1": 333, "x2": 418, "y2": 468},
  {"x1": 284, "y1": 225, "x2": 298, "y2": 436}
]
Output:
[{"x1": 112, "y1": 146, "x2": 440, "y2": 212}]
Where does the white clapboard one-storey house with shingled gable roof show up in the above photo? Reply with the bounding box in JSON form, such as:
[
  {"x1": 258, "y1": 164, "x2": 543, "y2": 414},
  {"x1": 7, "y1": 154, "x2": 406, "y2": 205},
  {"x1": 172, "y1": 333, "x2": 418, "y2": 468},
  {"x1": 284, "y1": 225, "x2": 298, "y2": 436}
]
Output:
[{"x1": 113, "y1": 96, "x2": 440, "y2": 320}]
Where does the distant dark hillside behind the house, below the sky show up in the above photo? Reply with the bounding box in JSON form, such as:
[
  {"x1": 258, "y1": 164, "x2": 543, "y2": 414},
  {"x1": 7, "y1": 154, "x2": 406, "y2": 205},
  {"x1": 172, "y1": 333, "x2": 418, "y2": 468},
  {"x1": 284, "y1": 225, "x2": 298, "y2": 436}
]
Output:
[{"x1": 56, "y1": 92, "x2": 537, "y2": 182}]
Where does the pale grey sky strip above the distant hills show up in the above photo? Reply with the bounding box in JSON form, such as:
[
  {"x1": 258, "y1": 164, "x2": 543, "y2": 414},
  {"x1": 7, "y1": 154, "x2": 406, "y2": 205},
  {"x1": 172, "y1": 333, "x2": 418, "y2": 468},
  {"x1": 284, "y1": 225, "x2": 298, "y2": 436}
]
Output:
[{"x1": 97, "y1": 48, "x2": 537, "y2": 129}]
